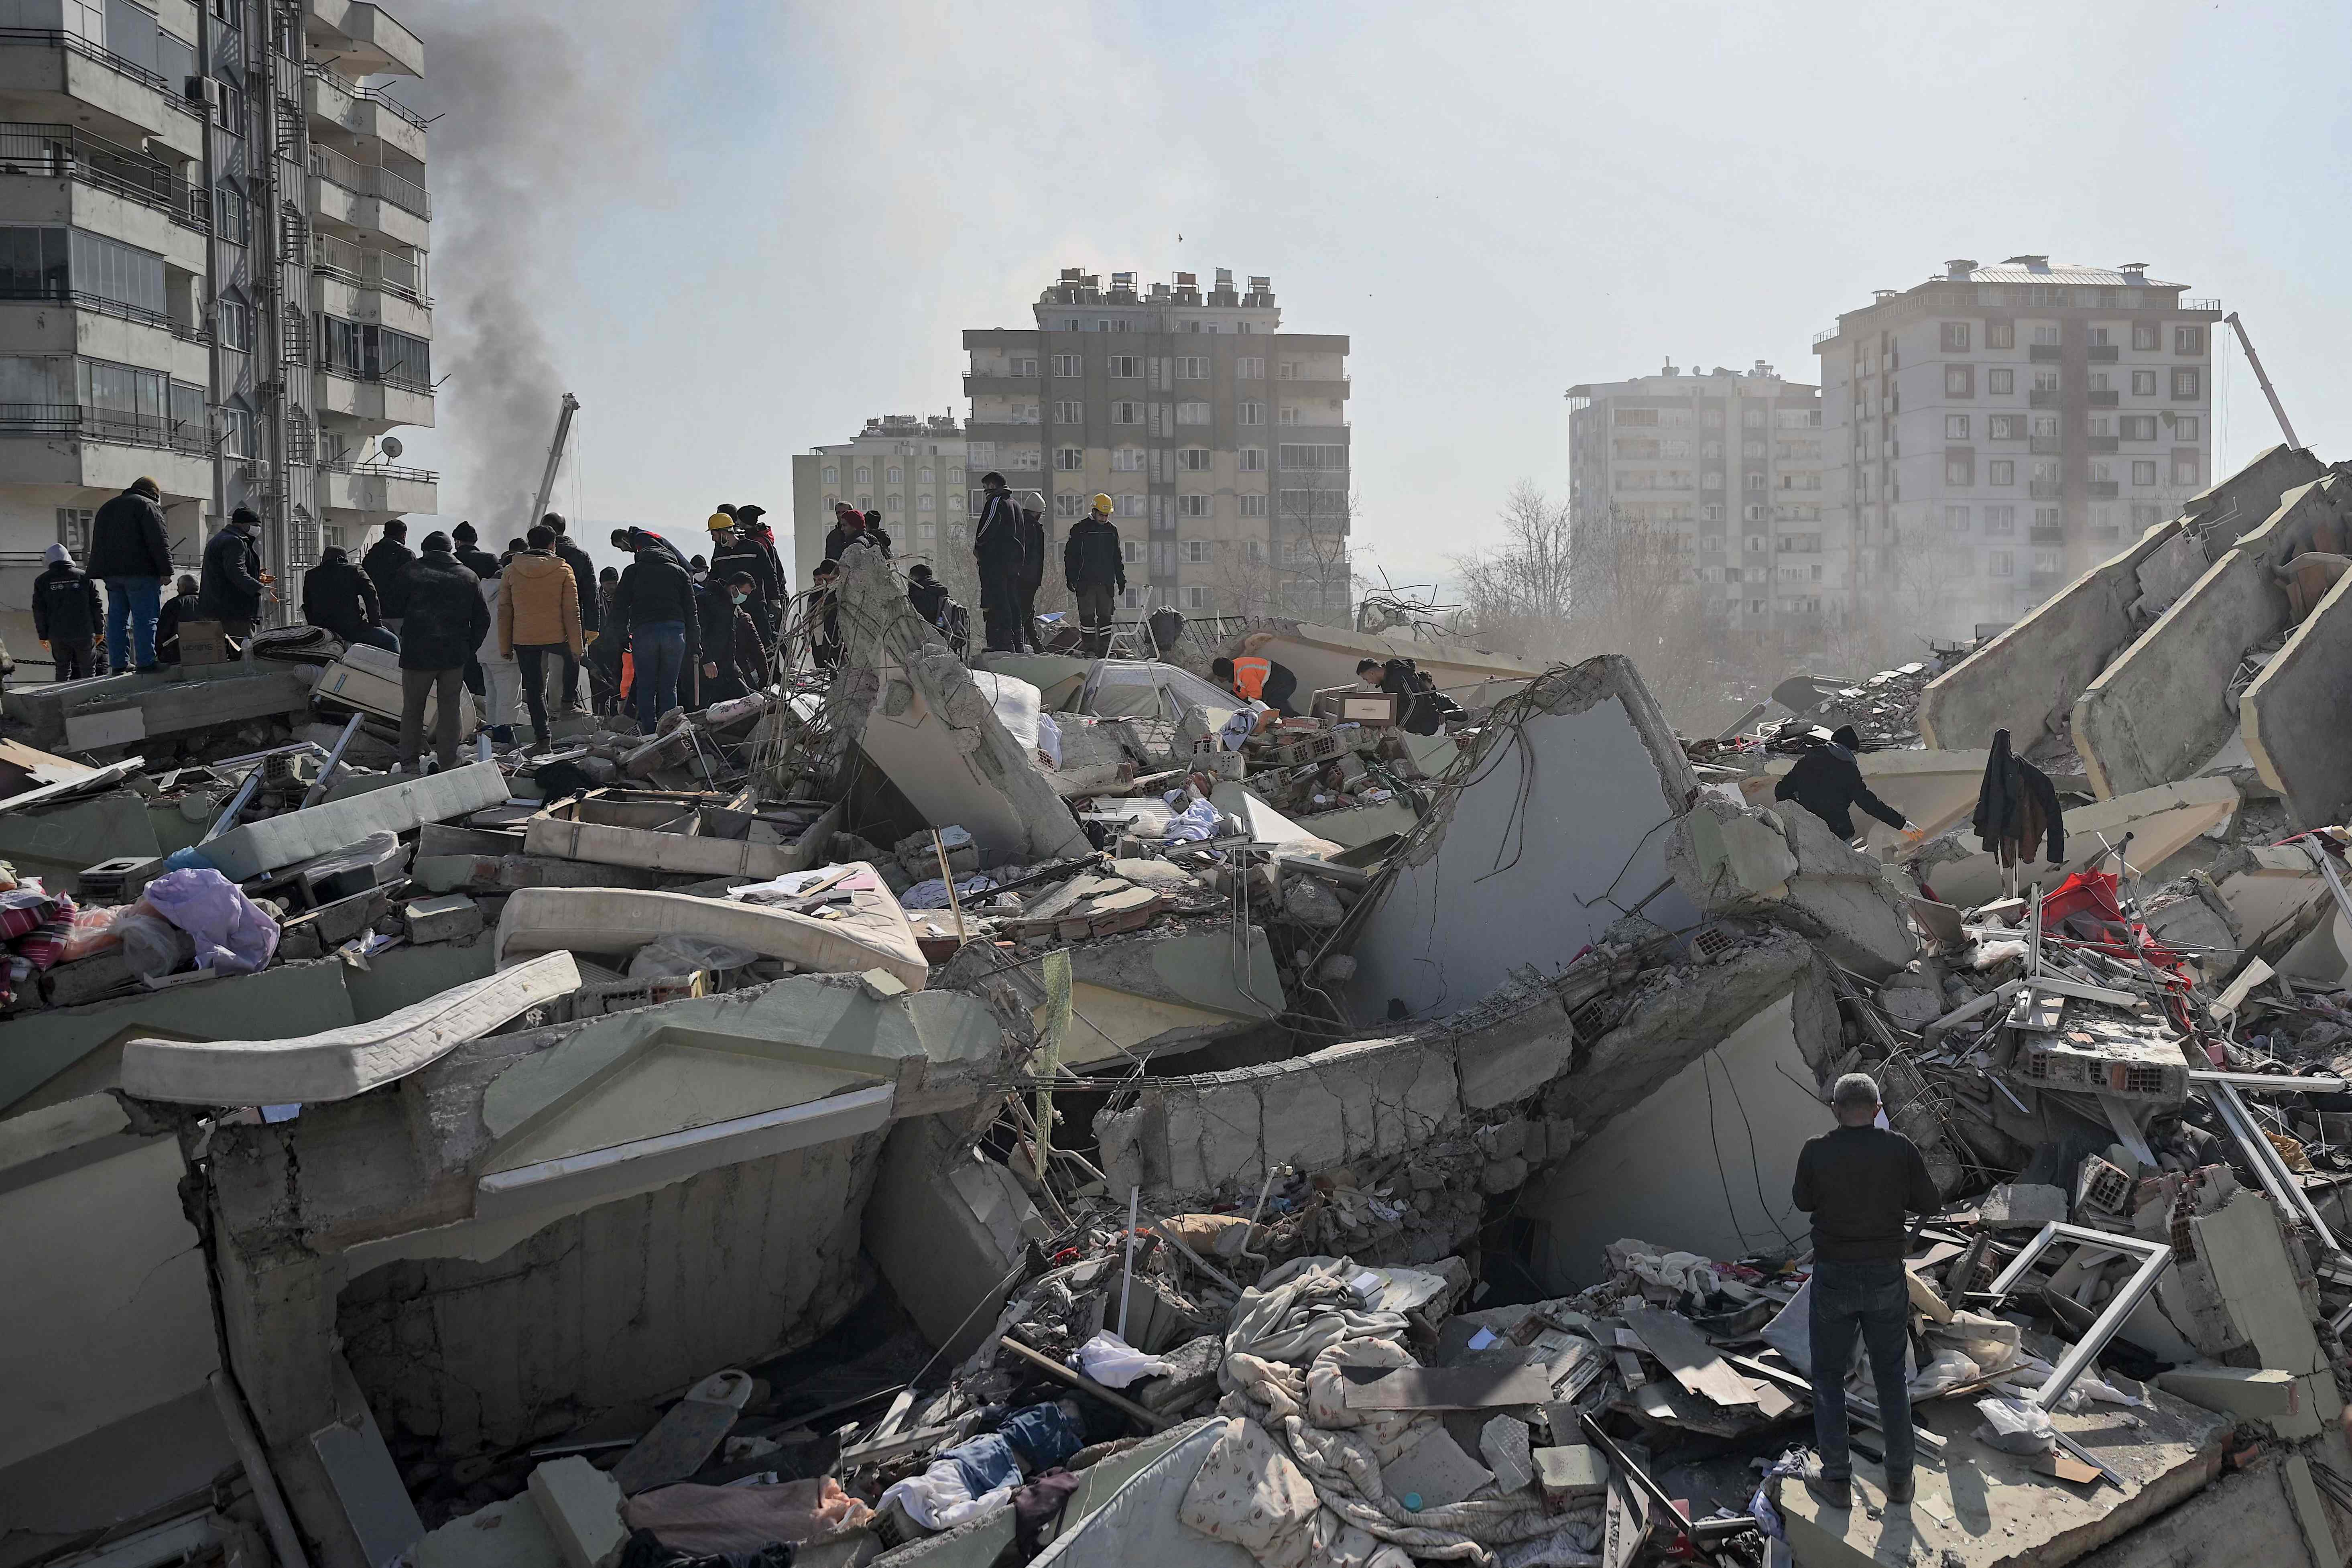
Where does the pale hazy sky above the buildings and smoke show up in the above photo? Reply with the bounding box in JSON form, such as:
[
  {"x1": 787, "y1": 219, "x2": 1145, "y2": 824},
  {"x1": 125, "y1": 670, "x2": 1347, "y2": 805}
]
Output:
[{"x1": 393, "y1": 0, "x2": 2352, "y2": 583}]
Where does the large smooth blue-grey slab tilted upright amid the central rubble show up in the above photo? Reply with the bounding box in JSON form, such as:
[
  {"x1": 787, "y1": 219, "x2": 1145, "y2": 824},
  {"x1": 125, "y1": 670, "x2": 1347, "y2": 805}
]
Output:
[{"x1": 1345, "y1": 653, "x2": 1698, "y2": 1020}]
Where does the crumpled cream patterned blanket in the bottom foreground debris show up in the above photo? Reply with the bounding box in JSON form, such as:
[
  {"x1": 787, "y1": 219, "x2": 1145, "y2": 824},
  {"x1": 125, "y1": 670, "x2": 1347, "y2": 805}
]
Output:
[{"x1": 1176, "y1": 1258, "x2": 1599, "y2": 1568}]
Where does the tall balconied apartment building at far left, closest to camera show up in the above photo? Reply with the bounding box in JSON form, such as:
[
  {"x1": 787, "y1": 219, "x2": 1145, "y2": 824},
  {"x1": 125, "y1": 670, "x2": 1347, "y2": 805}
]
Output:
[{"x1": 0, "y1": 0, "x2": 435, "y2": 656}]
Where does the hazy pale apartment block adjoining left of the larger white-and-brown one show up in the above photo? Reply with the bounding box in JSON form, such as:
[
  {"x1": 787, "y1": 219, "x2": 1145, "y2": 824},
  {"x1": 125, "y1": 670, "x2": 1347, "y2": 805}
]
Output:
[{"x1": 1569, "y1": 360, "x2": 1849, "y2": 642}]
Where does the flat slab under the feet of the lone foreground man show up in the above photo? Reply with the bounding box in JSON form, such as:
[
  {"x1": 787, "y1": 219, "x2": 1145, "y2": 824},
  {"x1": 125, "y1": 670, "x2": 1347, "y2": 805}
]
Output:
[{"x1": 1778, "y1": 1392, "x2": 2230, "y2": 1568}]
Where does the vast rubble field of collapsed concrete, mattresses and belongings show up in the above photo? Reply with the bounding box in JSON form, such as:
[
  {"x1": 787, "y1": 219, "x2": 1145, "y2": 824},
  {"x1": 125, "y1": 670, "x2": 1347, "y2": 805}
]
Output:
[{"x1": 14, "y1": 512, "x2": 2352, "y2": 1568}]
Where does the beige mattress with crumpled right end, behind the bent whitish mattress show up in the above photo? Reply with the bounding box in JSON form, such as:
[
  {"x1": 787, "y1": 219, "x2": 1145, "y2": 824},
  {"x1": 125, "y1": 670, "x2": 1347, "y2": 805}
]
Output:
[{"x1": 494, "y1": 879, "x2": 931, "y2": 990}]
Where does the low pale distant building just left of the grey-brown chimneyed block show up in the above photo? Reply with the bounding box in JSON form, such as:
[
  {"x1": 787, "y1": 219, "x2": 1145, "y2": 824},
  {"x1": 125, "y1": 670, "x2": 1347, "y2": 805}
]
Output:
[{"x1": 793, "y1": 414, "x2": 978, "y2": 588}]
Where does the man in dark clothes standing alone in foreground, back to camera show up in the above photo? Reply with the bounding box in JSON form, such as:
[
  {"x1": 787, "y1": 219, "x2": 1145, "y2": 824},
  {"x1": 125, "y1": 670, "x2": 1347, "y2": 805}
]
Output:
[{"x1": 1795, "y1": 1072, "x2": 1943, "y2": 1509}]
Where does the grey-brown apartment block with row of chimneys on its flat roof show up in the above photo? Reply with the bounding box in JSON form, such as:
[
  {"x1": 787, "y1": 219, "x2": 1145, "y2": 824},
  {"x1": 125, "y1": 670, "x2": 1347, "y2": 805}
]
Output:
[{"x1": 964, "y1": 268, "x2": 1352, "y2": 623}]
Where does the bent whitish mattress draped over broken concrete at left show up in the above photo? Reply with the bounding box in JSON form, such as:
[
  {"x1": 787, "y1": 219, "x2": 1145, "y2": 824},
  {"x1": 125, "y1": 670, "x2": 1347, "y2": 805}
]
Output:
[{"x1": 122, "y1": 952, "x2": 581, "y2": 1105}]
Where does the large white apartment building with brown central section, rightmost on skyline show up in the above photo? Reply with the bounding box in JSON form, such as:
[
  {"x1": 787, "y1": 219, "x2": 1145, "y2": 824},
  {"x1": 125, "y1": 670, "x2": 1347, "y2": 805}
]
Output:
[{"x1": 1813, "y1": 256, "x2": 2220, "y2": 637}]
